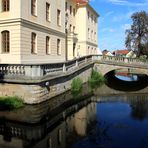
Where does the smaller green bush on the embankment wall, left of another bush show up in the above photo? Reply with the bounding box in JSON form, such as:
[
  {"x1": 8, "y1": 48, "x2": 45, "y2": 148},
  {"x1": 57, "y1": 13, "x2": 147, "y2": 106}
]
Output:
[{"x1": 71, "y1": 78, "x2": 83, "y2": 93}]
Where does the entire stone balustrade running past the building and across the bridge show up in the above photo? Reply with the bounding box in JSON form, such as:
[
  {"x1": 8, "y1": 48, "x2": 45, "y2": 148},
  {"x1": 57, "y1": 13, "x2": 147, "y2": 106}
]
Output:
[{"x1": 0, "y1": 55, "x2": 148, "y2": 80}]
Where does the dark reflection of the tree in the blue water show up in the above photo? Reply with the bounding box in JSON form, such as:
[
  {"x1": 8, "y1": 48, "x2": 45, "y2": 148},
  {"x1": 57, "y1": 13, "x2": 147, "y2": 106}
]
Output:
[{"x1": 129, "y1": 96, "x2": 148, "y2": 120}]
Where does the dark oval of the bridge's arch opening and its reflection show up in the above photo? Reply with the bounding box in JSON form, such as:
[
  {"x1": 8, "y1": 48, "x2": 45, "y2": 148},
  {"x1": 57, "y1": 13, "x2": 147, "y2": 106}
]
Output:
[{"x1": 105, "y1": 68, "x2": 148, "y2": 92}]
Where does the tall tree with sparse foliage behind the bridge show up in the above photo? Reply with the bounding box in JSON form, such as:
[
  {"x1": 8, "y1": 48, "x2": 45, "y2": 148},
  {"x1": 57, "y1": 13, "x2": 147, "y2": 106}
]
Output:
[{"x1": 125, "y1": 11, "x2": 148, "y2": 56}]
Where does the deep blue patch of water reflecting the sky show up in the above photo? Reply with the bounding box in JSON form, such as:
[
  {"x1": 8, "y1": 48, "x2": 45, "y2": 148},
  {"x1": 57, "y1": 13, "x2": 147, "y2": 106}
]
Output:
[{"x1": 72, "y1": 98, "x2": 148, "y2": 148}]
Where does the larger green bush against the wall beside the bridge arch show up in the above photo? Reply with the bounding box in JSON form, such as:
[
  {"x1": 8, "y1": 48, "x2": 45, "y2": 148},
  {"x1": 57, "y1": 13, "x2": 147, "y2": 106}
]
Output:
[{"x1": 88, "y1": 70, "x2": 106, "y2": 89}]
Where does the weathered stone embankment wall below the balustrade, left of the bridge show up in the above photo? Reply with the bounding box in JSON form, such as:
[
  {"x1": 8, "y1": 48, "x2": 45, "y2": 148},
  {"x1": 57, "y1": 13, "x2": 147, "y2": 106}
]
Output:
[{"x1": 0, "y1": 64, "x2": 93, "y2": 104}]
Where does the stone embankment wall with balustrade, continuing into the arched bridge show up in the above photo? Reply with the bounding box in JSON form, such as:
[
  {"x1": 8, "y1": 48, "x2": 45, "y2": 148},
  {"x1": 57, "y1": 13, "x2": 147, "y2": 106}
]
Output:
[{"x1": 0, "y1": 55, "x2": 148, "y2": 104}]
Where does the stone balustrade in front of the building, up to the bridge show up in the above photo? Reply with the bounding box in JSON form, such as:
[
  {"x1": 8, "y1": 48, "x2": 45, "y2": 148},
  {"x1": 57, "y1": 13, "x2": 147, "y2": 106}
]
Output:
[{"x1": 0, "y1": 56, "x2": 92, "y2": 80}]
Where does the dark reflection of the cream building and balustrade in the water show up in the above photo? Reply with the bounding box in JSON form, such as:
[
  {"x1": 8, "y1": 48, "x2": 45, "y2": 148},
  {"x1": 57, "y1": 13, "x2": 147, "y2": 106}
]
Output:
[{"x1": 0, "y1": 101, "x2": 96, "y2": 148}]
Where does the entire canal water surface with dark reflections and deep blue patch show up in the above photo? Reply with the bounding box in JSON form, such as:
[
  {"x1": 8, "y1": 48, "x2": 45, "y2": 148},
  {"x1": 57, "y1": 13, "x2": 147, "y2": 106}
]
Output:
[{"x1": 0, "y1": 72, "x2": 148, "y2": 148}]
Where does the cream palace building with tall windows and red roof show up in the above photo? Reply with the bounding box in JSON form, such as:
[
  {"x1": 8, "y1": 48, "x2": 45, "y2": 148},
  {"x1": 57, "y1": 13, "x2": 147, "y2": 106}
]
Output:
[{"x1": 0, "y1": 0, "x2": 99, "y2": 64}]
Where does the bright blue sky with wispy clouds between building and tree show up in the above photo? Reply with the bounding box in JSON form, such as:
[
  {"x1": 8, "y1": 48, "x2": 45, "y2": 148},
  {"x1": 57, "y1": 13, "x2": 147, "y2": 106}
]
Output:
[{"x1": 90, "y1": 0, "x2": 148, "y2": 51}]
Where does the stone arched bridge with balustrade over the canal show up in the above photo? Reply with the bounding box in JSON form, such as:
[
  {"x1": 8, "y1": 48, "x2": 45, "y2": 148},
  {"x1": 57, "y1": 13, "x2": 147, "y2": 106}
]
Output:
[{"x1": 94, "y1": 56, "x2": 148, "y2": 75}]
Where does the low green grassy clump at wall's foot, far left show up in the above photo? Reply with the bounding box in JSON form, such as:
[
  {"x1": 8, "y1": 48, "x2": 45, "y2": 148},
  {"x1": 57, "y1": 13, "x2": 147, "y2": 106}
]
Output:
[{"x1": 0, "y1": 96, "x2": 24, "y2": 110}]
